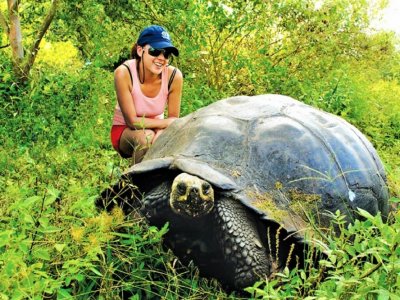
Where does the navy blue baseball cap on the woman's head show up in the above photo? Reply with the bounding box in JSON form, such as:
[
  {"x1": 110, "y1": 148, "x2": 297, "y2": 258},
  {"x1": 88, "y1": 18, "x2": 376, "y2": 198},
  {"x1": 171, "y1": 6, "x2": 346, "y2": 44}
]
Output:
[{"x1": 137, "y1": 25, "x2": 179, "y2": 56}]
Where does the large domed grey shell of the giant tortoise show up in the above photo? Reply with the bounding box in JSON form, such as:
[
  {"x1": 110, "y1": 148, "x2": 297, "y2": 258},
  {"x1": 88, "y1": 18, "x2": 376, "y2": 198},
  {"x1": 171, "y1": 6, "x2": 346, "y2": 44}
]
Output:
[{"x1": 127, "y1": 95, "x2": 389, "y2": 237}]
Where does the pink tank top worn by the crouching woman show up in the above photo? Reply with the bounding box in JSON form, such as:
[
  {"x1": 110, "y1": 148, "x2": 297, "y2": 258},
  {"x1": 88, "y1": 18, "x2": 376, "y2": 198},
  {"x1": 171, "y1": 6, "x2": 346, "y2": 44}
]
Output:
[{"x1": 113, "y1": 59, "x2": 168, "y2": 125}]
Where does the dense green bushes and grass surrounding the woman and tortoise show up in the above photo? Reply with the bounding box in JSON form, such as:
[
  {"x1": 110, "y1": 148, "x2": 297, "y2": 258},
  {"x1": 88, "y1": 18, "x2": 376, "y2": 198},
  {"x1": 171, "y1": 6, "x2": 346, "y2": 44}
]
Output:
[{"x1": 0, "y1": 0, "x2": 400, "y2": 299}]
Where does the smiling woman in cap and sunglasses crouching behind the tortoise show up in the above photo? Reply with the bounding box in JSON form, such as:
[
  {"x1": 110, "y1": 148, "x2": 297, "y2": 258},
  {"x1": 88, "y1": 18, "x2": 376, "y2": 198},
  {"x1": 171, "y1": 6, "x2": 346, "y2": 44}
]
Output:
[{"x1": 111, "y1": 25, "x2": 183, "y2": 163}]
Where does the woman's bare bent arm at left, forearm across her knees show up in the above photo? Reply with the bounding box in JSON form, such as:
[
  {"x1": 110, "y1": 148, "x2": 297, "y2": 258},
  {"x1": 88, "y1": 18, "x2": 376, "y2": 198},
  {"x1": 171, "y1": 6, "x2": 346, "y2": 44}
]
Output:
[{"x1": 114, "y1": 65, "x2": 175, "y2": 129}]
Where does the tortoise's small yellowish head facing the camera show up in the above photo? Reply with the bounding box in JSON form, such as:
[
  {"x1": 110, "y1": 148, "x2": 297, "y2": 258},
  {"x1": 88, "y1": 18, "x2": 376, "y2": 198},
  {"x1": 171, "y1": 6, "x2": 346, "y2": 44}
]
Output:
[{"x1": 169, "y1": 173, "x2": 214, "y2": 218}]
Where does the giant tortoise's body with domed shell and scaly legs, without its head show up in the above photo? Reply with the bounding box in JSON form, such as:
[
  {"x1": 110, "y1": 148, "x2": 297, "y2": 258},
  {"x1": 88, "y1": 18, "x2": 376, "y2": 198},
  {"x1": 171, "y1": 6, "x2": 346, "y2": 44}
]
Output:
[{"x1": 96, "y1": 95, "x2": 388, "y2": 289}]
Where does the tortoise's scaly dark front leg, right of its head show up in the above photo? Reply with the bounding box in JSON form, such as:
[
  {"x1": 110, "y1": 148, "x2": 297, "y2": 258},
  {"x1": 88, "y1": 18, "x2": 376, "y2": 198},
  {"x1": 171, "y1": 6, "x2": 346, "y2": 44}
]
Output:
[{"x1": 214, "y1": 198, "x2": 271, "y2": 289}]
